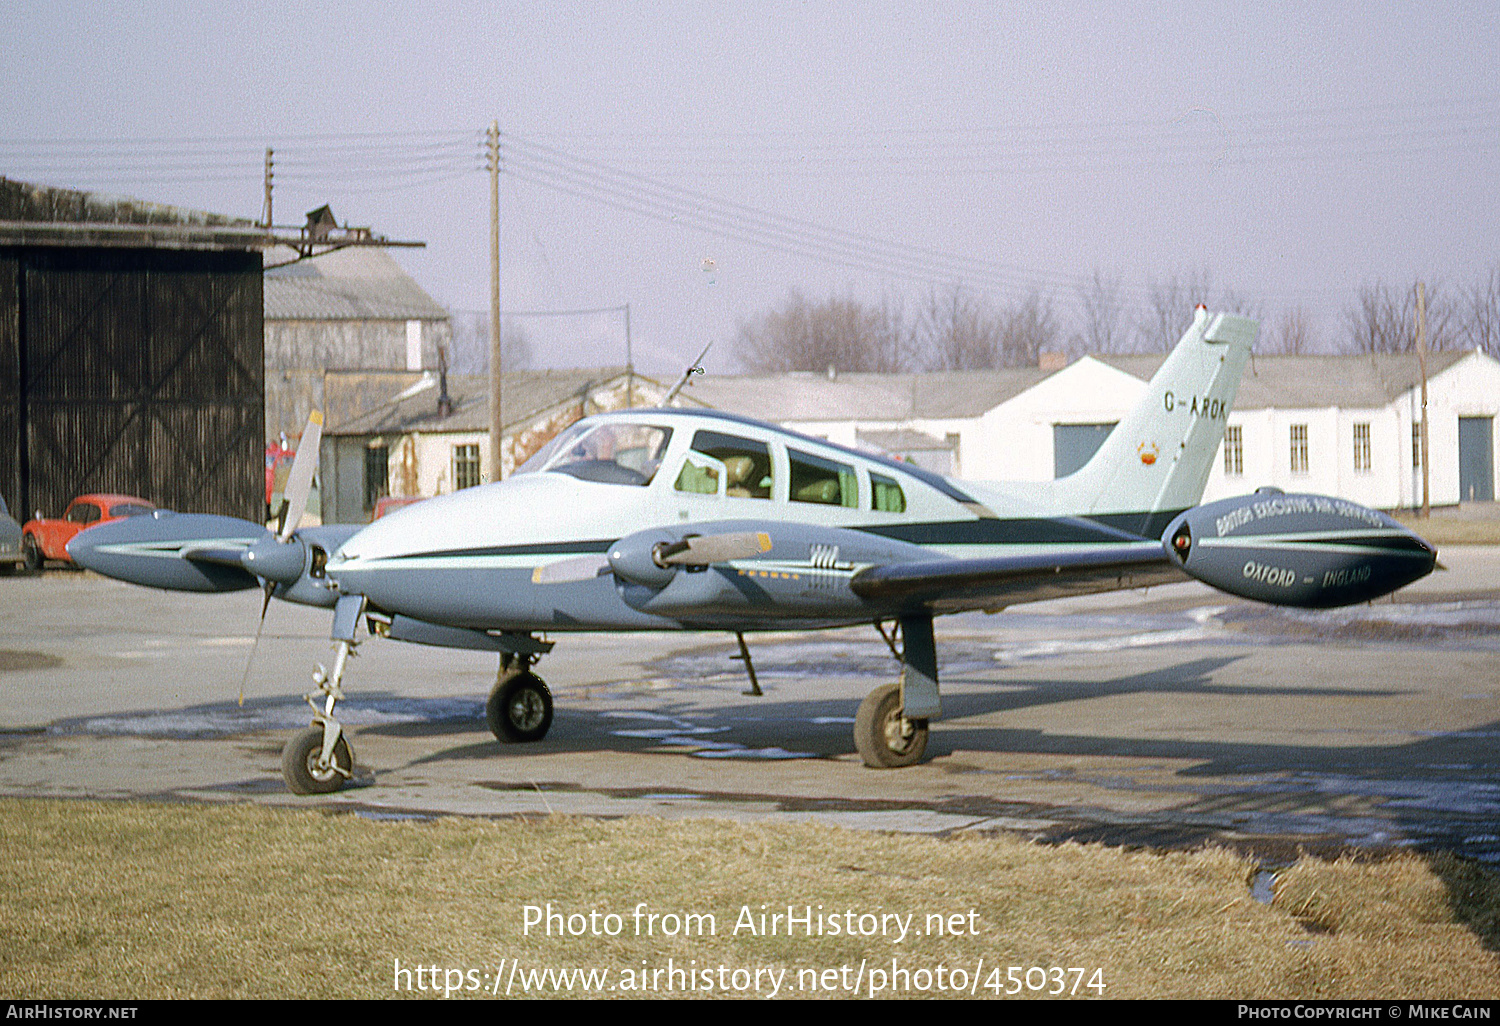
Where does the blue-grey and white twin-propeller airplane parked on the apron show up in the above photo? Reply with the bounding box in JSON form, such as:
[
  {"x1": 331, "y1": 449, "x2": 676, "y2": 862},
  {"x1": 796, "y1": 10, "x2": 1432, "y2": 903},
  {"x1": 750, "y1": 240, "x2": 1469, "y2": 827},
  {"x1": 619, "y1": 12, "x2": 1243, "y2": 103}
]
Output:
[{"x1": 68, "y1": 308, "x2": 1437, "y2": 794}]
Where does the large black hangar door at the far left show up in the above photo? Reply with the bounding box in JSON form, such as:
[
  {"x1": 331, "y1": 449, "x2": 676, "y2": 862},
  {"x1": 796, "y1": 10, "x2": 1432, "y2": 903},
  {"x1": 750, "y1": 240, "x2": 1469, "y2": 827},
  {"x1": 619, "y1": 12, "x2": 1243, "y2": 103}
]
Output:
[{"x1": 0, "y1": 246, "x2": 266, "y2": 521}]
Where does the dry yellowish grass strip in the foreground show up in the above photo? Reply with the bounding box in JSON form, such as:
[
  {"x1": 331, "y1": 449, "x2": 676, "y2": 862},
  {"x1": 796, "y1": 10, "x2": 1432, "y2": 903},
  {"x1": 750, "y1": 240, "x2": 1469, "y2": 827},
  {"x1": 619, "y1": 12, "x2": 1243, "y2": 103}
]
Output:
[{"x1": 0, "y1": 800, "x2": 1500, "y2": 999}]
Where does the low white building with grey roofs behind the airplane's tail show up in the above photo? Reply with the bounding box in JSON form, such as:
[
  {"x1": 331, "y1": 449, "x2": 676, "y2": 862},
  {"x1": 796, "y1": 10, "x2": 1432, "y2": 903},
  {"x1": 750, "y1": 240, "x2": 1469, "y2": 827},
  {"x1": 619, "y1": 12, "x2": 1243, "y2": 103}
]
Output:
[{"x1": 689, "y1": 353, "x2": 1500, "y2": 509}]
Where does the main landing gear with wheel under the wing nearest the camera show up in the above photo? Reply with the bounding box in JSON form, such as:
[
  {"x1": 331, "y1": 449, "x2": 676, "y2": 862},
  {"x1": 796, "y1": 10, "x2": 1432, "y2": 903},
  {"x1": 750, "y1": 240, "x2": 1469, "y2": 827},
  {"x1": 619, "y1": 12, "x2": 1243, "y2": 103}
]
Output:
[{"x1": 854, "y1": 617, "x2": 942, "y2": 770}]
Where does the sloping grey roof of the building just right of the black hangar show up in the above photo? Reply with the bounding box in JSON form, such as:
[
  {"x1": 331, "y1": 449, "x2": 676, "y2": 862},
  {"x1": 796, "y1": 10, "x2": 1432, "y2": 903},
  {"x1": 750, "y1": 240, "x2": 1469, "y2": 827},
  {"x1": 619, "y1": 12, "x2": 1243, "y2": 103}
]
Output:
[{"x1": 266, "y1": 246, "x2": 449, "y2": 321}]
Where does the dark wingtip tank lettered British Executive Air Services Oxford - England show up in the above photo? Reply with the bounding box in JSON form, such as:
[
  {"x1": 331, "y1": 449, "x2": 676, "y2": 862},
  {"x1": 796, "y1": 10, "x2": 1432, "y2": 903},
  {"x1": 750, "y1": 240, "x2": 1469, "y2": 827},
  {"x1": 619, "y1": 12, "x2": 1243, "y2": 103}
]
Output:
[{"x1": 1163, "y1": 489, "x2": 1437, "y2": 609}]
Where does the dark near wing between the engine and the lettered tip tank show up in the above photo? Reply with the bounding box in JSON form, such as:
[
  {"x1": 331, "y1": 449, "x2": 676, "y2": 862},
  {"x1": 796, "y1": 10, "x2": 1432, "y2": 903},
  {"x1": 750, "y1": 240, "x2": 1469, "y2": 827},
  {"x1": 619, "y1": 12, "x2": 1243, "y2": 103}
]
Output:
[{"x1": 849, "y1": 542, "x2": 1188, "y2": 614}]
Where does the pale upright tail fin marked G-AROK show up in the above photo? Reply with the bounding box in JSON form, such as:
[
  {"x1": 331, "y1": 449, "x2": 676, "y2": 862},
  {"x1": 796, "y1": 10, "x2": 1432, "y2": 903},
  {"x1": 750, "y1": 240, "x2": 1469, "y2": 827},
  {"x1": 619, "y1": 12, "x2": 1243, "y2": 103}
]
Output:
[{"x1": 1056, "y1": 306, "x2": 1260, "y2": 537}]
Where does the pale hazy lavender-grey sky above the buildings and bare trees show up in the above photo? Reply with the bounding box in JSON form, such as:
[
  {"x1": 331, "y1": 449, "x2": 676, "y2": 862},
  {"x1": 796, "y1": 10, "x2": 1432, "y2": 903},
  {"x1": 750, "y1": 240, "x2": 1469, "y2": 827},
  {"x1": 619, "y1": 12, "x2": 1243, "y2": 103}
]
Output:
[{"x1": 0, "y1": 0, "x2": 1500, "y2": 377}]
